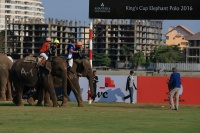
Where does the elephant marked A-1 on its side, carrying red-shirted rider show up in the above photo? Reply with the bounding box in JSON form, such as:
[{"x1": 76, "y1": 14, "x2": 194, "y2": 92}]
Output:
[{"x1": 11, "y1": 57, "x2": 68, "y2": 107}]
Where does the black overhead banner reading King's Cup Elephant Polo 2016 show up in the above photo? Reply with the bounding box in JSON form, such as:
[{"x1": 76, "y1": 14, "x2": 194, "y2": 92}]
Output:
[{"x1": 89, "y1": 0, "x2": 200, "y2": 20}]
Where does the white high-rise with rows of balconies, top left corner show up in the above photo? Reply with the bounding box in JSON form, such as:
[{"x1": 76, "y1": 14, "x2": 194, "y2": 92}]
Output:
[{"x1": 0, "y1": 0, "x2": 44, "y2": 31}]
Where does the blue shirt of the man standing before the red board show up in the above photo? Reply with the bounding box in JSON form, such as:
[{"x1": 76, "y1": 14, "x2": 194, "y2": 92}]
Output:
[{"x1": 170, "y1": 72, "x2": 181, "y2": 89}]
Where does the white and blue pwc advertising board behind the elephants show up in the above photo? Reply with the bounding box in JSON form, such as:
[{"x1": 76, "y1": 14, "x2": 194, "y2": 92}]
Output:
[{"x1": 70, "y1": 75, "x2": 137, "y2": 103}]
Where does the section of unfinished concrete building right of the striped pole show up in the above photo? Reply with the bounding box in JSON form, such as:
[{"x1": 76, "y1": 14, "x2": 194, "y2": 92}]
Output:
[{"x1": 93, "y1": 19, "x2": 162, "y2": 66}]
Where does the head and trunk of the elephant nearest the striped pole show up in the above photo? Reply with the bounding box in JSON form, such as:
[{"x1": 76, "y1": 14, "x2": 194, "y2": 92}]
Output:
[{"x1": 78, "y1": 58, "x2": 94, "y2": 97}]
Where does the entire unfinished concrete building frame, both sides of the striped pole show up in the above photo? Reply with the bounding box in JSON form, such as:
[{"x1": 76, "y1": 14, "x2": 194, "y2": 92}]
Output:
[{"x1": 5, "y1": 19, "x2": 162, "y2": 68}]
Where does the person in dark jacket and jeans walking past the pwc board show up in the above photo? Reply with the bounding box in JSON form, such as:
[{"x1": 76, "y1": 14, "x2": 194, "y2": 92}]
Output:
[{"x1": 123, "y1": 70, "x2": 137, "y2": 104}]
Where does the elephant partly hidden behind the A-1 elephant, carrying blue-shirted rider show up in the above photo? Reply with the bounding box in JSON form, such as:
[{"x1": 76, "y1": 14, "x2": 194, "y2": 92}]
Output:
[{"x1": 28, "y1": 58, "x2": 94, "y2": 107}]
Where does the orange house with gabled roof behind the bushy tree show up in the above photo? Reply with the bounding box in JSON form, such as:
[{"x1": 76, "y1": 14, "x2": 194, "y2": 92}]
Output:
[{"x1": 164, "y1": 25, "x2": 194, "y2": 50}]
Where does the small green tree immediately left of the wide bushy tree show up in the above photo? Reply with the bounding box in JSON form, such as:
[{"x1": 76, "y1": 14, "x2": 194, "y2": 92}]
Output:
[{"x1": 130, "y1": 51, "x2": 146, "y2": 67}]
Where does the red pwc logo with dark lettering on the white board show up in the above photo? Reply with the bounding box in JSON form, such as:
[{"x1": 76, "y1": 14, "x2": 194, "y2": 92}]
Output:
[{"x1": 97, "y1": 77, "x2": 115, "y2": 98}]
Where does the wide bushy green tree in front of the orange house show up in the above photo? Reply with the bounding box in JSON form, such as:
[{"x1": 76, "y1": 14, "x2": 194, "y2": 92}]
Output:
[{"x1": 150, "y1": 45, "x2": 182, "y2": 63}]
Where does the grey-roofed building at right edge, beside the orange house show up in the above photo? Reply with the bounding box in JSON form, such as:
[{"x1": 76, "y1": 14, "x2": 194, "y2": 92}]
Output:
[{"x1": 183, "y1": 32, "x2": 200, "y2": 63}]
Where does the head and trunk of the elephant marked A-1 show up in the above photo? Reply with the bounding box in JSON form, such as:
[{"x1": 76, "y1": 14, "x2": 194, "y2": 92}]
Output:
[{"x1": 45, "y1": 57, "x2": 68, "y2": 97}]
